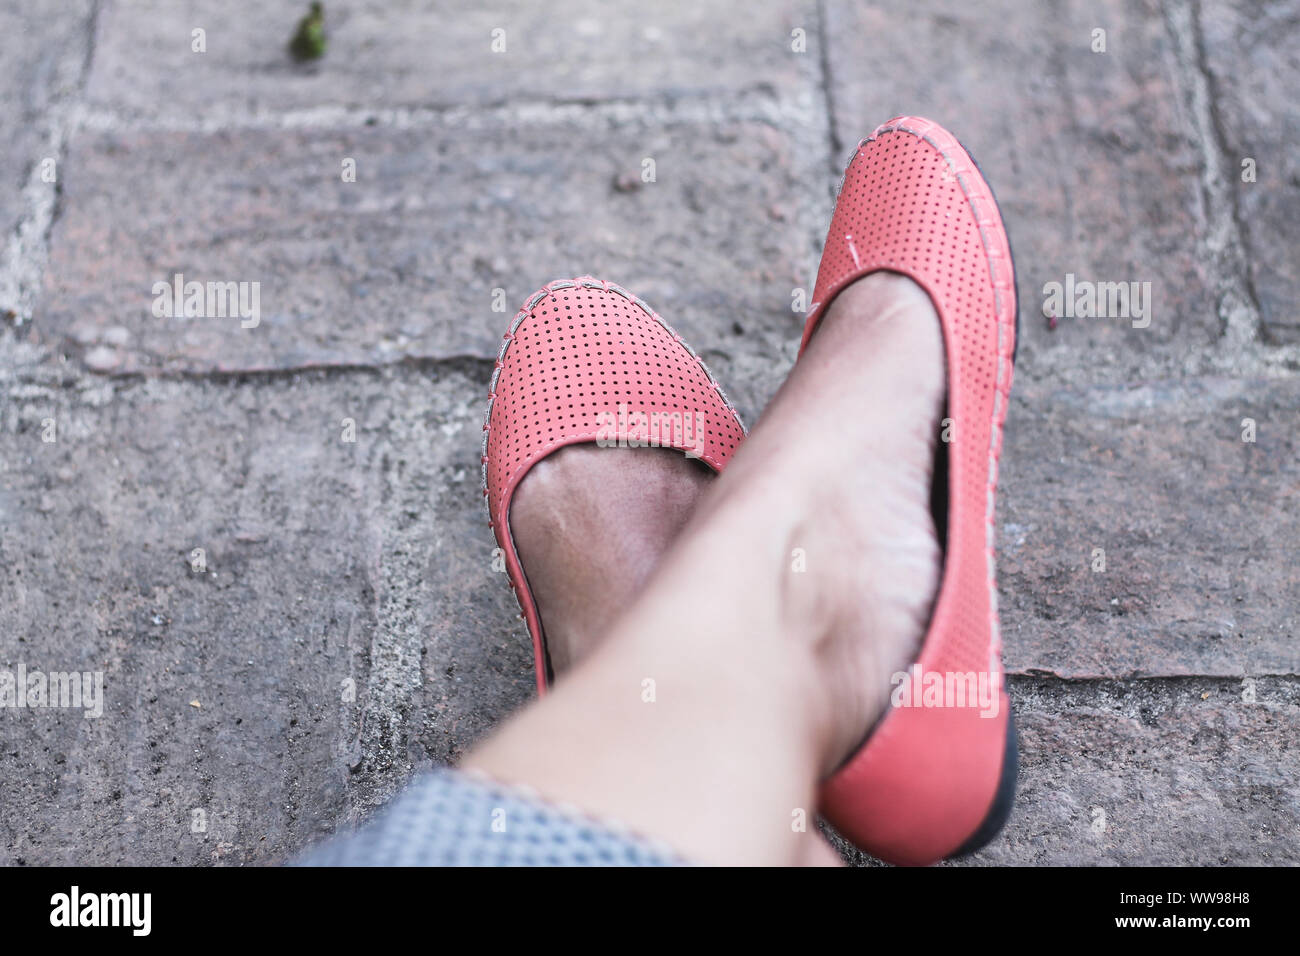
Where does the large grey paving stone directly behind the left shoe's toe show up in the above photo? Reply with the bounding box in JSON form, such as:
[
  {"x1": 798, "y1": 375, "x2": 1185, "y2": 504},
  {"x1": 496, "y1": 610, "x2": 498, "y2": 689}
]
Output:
[{"x1": 45, "y1": 120, "x2": 819, "y2": 418}]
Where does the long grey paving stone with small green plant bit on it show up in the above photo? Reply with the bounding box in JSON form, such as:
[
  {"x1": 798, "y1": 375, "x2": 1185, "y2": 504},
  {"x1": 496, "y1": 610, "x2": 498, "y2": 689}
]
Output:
[{"x1": 87, "y1": 0, "x2": 818, "y2": 117}]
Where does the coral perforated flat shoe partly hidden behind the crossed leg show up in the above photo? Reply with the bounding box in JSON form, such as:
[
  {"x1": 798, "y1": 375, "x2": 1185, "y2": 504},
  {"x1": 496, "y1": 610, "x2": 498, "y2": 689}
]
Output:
[{"x1": 482, "y1": 276, "x2": 745, "y2": 693}]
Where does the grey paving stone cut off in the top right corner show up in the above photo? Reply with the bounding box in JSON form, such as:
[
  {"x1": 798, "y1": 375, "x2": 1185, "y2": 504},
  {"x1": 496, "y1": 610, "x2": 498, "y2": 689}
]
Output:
[{"x1": 1199, "y1": 3, "x2": 1300, "y2": 343}]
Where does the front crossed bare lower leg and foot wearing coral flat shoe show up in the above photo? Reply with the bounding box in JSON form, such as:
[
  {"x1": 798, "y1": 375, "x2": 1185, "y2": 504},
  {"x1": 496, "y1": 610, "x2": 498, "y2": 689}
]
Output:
[{"x1": 468, "y1": 117, "x2": 1015, "y2": 864}]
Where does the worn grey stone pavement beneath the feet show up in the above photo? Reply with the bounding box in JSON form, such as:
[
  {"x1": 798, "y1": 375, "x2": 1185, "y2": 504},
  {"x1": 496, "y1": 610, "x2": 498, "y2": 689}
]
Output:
[{"x1": 0, "y1": 0, "x2": 1300, "y2": 865}]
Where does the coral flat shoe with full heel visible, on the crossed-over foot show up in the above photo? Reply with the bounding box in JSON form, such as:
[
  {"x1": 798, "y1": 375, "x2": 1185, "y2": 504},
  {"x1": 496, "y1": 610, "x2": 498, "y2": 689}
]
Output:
[{"x1": 801, "y1": 116, "x2": 1018, "y2": 865}]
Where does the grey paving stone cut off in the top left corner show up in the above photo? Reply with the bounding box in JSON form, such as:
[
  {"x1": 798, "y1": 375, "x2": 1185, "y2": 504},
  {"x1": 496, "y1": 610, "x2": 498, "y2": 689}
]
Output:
[{"x1": 0, "y1": 0, "x2": 91, "y2": 273}]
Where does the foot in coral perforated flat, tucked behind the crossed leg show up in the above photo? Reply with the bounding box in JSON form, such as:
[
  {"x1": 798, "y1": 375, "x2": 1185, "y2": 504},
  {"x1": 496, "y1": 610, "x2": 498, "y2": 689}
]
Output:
[{"x1": 481, "y1": 276, "x2": 745, "y2": 693}]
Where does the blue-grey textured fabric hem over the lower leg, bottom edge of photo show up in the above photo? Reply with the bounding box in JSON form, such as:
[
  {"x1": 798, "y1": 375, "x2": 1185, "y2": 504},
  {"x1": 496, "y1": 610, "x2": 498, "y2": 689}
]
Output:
[{"x1": 299, "y1": 770, "x2": 684, "y2": 866}]
